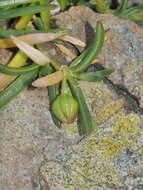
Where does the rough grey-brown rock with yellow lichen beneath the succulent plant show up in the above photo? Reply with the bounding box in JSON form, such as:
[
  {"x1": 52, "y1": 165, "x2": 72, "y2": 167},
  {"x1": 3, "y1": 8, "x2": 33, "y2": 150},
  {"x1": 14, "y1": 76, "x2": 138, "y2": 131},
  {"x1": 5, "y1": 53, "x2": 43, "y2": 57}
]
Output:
[{"x1": 0, "y1": 7, "x2": 143, "y2": 190}]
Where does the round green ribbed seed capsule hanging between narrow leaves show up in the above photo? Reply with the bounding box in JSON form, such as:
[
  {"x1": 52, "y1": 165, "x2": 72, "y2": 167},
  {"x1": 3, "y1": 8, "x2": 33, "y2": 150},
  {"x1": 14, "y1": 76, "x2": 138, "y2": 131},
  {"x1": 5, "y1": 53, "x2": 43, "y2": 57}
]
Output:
[{"x1": 52, "y1": 94, "x2": 78, "y2": 123}]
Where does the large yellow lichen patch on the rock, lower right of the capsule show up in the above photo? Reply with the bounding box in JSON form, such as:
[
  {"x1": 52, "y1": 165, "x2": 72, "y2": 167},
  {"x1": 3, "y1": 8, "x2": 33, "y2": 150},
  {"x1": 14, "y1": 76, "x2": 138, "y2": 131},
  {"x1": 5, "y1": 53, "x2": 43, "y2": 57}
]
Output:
[{"x1": 42, "y1": 81, "x2": 143, "y2": 190}]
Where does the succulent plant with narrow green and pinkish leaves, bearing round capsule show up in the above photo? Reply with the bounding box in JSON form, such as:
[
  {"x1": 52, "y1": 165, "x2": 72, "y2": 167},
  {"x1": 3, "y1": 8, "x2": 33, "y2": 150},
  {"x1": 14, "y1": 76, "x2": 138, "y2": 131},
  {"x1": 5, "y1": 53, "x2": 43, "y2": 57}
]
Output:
[{"x1": 0, "y1": 0, "x2": 113, "y2": 135}]
